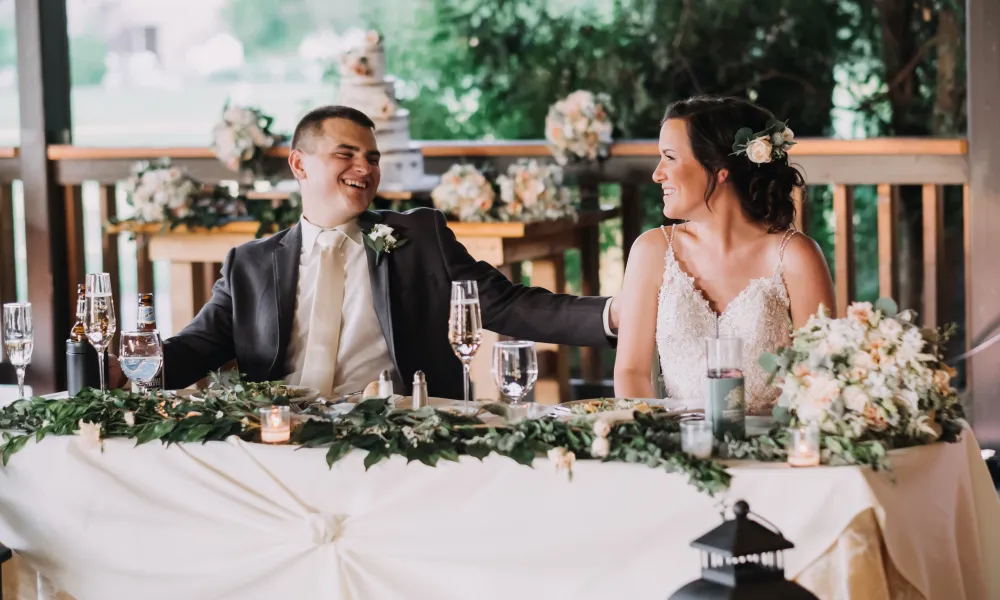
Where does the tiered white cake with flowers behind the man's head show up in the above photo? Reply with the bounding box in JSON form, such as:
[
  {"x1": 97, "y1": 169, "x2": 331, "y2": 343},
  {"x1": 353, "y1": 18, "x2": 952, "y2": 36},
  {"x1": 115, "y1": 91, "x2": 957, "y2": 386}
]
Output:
[{"x1": 339, "y1": 31, "x2": 438, "y2": 192}]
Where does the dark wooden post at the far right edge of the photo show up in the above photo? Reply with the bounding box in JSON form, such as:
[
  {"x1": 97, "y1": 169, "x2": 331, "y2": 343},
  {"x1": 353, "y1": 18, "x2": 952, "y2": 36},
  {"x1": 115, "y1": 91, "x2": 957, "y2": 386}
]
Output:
[{"x1": 965, "y1": 0, "x2": 1000, "y2": 448}]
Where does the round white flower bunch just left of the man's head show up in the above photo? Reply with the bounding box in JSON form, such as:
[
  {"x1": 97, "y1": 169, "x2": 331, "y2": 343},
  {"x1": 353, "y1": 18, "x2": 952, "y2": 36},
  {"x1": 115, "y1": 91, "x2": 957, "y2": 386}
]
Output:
[{"x1": 212, "y1": 102, "x2": 287, "y2": 176}]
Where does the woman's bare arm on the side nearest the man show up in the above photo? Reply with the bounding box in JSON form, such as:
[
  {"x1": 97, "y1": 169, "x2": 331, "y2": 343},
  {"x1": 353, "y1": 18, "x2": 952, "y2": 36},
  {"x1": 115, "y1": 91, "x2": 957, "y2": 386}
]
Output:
[{"x1": 615, "y1": 229, "x2": 667, "y2": 398}]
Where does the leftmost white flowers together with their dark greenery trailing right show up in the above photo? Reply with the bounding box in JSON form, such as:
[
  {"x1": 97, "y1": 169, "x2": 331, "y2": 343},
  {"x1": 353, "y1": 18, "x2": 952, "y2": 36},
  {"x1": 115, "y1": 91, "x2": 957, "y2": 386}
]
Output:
[{"x1": 115, "y1": 159, "x2": 246, "y2": 229}]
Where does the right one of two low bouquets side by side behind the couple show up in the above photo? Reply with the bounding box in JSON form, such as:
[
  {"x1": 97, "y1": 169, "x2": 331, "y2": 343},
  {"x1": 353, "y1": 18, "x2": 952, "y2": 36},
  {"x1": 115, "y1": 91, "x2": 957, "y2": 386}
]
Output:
[{"x1": 497, "y1": 159, "x2": 576, "y2": 221}]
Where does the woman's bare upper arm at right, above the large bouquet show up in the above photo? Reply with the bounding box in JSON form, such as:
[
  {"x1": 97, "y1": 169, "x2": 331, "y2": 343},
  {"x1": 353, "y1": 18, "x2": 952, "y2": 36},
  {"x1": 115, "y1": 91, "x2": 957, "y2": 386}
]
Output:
[{"x1": 784, "y1": 235, "x2": 837, "y2": 329}]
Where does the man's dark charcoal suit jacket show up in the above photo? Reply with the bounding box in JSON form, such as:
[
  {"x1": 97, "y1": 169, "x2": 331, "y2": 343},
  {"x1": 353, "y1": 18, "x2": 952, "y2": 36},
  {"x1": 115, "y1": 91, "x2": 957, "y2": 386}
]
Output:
[{"x1": 163, "y1": 208, "x2": 610, "y2": 398}]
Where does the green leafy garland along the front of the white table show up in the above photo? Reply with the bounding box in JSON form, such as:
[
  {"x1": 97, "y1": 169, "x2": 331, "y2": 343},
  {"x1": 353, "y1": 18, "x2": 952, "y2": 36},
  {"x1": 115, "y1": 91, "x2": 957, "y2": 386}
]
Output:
[{"x1": 0, "y1": 375, "x2": 730, "y2": 495}]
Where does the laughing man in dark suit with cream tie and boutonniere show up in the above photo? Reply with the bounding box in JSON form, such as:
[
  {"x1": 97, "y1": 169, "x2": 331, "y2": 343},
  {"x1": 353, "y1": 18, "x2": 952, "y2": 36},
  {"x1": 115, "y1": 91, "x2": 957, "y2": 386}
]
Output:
[{"x1": 157, "y1": 106, "x2": 617, "y2": 398}]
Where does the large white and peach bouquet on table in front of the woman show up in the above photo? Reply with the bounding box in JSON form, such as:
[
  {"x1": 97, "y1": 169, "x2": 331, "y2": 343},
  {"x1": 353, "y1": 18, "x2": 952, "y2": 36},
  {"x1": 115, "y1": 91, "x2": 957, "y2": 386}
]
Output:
[{"x1": 730, "y1": 299, "x2": 965, "y2": 467}]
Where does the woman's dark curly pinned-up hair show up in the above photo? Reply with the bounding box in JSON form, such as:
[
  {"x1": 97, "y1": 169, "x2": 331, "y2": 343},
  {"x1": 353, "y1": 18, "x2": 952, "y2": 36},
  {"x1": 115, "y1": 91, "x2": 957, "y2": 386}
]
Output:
[{"x1": 661, "y1": 96, "x2": 805, "y2": 231}]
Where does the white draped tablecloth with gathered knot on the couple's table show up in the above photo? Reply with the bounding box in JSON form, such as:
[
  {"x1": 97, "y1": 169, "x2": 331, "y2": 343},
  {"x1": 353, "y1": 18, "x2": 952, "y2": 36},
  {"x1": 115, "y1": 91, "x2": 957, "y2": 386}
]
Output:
[{"x1": 0, "y1": 434, "x2": 1000, "y2": 600}]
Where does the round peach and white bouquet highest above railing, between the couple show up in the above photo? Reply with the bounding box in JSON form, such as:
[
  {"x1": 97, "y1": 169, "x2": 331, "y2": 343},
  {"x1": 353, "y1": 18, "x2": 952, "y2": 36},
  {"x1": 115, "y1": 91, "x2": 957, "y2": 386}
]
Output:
[{"x1": 545, "y1": 90, "x2": 614, "y2": 165}]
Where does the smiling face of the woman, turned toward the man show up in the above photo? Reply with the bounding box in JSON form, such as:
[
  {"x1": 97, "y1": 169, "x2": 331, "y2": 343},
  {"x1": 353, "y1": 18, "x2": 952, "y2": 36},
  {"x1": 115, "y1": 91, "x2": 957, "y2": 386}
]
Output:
[{"x1": 653, "y1": 119, "x2": 708, "y2": 221}]
